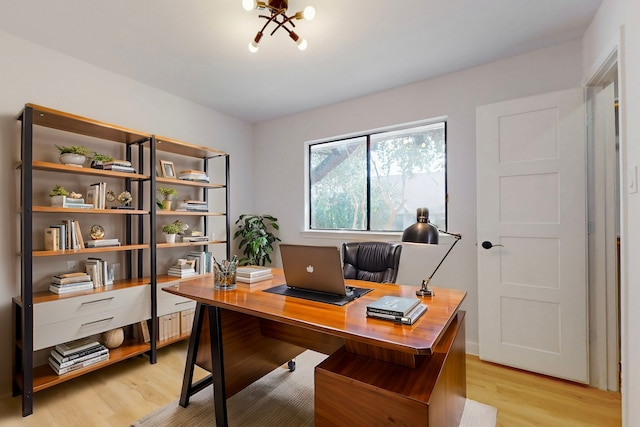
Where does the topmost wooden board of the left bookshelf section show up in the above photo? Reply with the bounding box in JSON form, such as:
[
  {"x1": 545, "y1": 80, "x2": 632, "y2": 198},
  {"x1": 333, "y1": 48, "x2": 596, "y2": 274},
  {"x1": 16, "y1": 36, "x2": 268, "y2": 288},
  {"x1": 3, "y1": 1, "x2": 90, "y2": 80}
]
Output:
[{"x1": 18, "y1": 104, "x2": 151, "y2": 143}]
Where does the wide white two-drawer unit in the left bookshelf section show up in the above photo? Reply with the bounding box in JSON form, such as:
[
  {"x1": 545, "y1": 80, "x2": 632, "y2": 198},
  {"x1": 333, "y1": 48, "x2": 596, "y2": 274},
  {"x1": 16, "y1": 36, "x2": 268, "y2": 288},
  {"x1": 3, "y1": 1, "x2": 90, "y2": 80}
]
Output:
[{"x1": 33, "y1": 285, "x2": 151, "y2": 350}]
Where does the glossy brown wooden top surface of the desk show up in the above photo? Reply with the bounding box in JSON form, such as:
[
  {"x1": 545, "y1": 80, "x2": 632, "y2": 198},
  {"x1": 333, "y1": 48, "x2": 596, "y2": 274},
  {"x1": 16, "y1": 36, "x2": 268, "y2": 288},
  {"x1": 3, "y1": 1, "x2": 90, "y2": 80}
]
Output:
[{"x1": 163, "y1": 268, "x2": 466, "y2": 355}]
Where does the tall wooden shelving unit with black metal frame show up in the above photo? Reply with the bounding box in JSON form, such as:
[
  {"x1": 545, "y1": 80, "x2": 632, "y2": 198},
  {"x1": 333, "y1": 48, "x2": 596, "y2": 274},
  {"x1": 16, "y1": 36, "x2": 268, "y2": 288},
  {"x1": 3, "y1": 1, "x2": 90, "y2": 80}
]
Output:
[{"x1": 12, "y1": 104, "x2": 230, "y2": 416}]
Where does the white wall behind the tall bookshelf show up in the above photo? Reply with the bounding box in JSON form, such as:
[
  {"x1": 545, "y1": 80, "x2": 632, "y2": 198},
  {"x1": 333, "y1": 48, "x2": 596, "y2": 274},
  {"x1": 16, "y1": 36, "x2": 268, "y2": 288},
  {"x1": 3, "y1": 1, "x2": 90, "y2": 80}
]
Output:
[{"x1": 0, "y1": 32, "x2": 253, "y2": 395}]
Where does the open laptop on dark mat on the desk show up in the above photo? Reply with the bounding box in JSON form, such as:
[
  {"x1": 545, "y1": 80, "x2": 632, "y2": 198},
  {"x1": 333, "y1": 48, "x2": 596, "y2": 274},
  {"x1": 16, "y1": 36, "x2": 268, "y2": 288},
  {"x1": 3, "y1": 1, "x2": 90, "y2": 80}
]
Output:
[{"x1": 265, "y1": 244, "x2": 372, "y2": 305}]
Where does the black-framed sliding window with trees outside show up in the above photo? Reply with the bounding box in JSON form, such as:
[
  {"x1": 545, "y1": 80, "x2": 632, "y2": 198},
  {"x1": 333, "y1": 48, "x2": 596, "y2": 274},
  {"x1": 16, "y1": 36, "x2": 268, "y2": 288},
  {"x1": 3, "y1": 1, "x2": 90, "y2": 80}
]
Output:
[{"x1": 308, "y1": 122, "x2": 447, "y2": 231}]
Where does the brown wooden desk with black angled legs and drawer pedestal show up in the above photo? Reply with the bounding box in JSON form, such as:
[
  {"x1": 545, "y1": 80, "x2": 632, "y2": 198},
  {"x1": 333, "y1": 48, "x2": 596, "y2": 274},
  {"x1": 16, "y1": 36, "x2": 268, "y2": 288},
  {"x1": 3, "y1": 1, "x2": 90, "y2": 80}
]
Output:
[{"x1": 163, "y1": 269, "x2": 466, "y2": 427}]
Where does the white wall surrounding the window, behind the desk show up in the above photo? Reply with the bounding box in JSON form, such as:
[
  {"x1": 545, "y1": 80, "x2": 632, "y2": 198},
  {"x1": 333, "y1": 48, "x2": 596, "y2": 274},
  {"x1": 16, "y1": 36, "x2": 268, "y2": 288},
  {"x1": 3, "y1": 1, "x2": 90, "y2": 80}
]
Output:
[{"x1": 253, "y1": 41, "x2": 582, "y2": 352}]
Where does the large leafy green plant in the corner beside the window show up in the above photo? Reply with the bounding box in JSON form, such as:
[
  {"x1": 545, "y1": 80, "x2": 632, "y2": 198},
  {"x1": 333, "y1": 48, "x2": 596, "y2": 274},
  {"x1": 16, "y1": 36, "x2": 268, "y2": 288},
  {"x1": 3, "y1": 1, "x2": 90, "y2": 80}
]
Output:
[{"x1": 233, "y1": 214, "x2": 280, "y2": 265}]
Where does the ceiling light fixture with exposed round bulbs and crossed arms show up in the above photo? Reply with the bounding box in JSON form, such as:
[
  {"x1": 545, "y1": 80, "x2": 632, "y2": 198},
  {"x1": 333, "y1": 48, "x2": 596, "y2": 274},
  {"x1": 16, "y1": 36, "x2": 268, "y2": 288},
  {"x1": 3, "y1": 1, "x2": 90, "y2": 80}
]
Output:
[{"x1": 242, "y1": 0, "x2": 316, "y2": 53}]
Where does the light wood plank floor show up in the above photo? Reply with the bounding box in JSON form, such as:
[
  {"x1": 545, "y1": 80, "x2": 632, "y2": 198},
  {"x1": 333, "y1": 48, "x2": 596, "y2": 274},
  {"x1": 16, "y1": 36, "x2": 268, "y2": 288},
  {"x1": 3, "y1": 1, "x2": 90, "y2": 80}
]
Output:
[{"x1": 0, "y1": 342, "x2": 621, "y2": 427}]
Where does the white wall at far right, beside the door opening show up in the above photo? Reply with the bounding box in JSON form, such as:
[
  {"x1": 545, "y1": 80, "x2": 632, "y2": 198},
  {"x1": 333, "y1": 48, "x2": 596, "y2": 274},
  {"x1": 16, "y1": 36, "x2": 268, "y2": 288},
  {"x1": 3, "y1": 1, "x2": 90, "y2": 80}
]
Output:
[{"x1": 583, "y1": 0, "x2": 640, "y2": 426}]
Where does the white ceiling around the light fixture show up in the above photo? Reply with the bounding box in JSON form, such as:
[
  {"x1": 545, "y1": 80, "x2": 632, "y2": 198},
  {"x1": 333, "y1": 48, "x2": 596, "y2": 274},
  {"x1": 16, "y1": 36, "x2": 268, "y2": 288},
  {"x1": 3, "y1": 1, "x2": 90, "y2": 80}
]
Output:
[{"x1": 0, "y1": 0, "x2": 602, "y2": 122}]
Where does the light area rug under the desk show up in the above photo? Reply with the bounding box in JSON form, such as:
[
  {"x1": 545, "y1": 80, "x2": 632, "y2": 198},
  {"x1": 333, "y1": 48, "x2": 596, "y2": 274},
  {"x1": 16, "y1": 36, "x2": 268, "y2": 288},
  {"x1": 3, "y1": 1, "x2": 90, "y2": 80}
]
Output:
[{"x1": 132, "y1": 351, "x2": 498, "y2": 427}]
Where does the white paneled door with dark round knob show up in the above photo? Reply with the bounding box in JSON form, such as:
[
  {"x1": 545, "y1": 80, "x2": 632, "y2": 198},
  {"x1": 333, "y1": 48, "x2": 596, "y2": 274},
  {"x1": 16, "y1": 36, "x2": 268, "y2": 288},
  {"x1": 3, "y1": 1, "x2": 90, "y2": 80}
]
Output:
[{"x1": 476, "y1": 89, "x2": 589, "y2": 383}]
